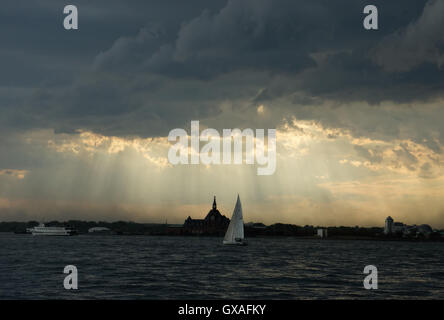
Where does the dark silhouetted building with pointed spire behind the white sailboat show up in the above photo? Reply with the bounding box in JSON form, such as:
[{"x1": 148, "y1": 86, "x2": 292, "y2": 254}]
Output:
[{"x1": 183, "y1": 196, "x2": 230, "y2": 235}]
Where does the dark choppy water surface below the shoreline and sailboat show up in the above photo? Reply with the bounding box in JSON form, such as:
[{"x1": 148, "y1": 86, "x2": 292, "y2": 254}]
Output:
[{"x1": 0, "y1": 234, "x2": 444, "y2": 299}]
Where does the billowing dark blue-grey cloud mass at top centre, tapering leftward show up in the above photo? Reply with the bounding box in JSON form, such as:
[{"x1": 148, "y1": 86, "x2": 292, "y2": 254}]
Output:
[{"x1": 96, "y1": 0, "x2": 378, "y2": 79}]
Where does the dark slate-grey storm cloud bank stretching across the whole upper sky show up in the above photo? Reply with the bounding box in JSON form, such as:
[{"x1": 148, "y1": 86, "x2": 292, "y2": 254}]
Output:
[{"x1": 0, "y1": 0, "x2": 444, "y2": 144}]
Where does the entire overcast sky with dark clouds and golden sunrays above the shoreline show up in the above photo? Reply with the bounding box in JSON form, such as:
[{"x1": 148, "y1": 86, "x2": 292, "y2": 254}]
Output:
[{"x1": 0, "y1": 0, "x2": 444, "y2": 227}]
